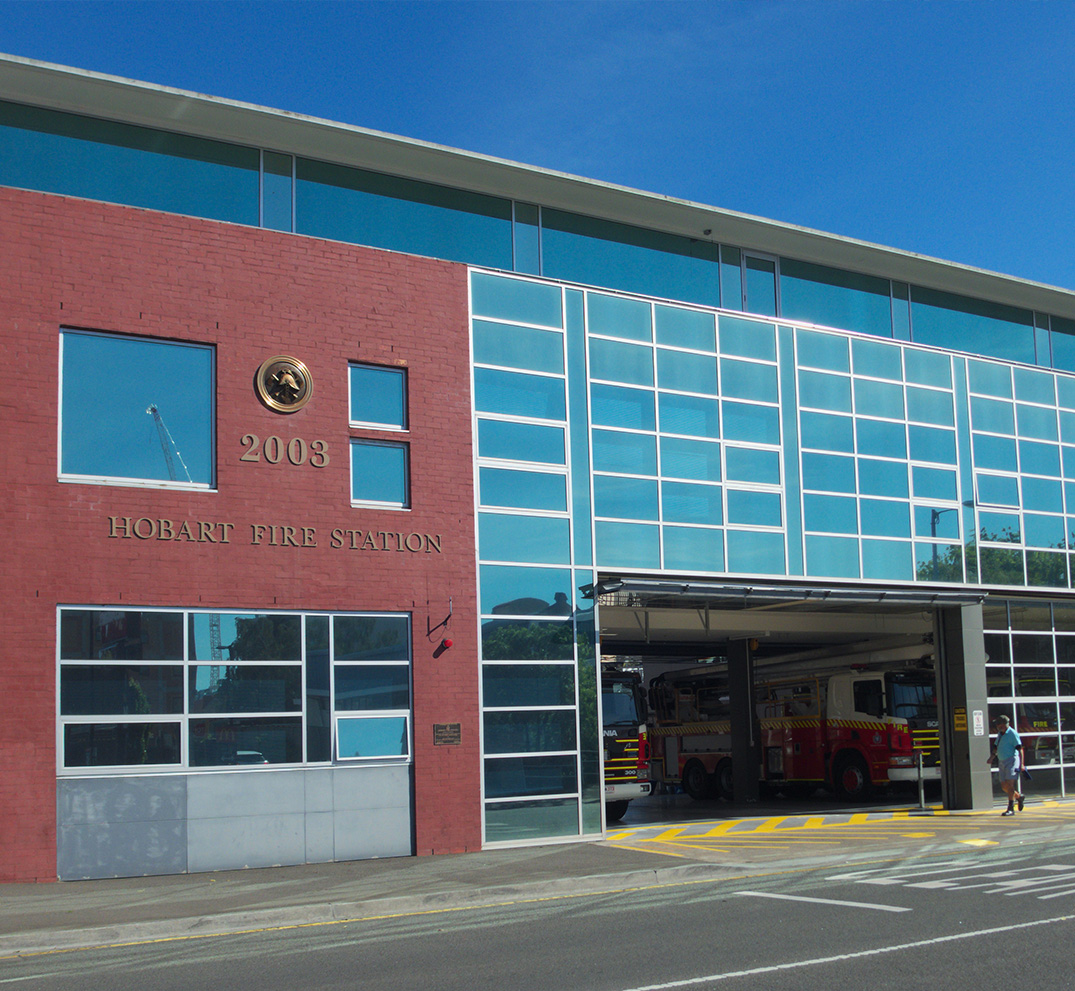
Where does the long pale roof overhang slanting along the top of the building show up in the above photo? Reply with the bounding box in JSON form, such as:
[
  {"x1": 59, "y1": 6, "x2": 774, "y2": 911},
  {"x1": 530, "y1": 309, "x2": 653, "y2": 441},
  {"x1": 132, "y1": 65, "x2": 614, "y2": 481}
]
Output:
[{"x1": 6, "y1": 55, "x2": 1075, "y2": 319}]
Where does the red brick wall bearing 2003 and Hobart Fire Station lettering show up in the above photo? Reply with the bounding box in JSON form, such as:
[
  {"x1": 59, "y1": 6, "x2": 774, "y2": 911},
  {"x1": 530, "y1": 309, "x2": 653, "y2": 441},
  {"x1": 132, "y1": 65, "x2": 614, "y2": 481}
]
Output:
[{"x1": 0, "y1": 189, "x2": 481, "y2": 880}]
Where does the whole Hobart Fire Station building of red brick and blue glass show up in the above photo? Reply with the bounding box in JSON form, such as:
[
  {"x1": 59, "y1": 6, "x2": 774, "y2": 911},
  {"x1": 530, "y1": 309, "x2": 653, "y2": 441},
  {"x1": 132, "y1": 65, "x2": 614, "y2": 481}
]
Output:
[{"x1": 0, "y1": 56, "x2": 1075, "y2": 880}]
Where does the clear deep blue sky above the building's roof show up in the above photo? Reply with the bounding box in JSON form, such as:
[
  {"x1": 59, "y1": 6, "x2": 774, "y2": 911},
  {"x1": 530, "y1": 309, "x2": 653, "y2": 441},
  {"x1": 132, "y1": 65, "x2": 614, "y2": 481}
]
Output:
[{"x1": 0, "y1": 0, "x2": 1075, "y2": 289}]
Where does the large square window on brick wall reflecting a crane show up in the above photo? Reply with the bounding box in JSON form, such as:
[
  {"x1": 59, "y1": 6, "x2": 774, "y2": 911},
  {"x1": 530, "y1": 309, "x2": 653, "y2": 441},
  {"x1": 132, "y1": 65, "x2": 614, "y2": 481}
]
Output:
[{"x1": 60, "y1": 330, "x2": 216, "y2": 488}]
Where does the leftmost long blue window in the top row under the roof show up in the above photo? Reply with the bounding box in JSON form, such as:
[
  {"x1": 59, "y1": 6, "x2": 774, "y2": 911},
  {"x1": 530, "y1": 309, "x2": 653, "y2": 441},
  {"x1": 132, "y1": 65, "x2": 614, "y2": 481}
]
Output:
[{"x1": 0, "y1": 103, "x2": 260, "y2": 227}]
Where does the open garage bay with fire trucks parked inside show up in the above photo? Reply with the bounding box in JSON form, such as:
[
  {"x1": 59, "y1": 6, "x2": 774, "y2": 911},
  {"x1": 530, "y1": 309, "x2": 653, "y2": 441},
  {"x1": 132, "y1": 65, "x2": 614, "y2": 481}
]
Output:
[{"x1": 593, "y1": 576, "x2": 977, "y2": 825}]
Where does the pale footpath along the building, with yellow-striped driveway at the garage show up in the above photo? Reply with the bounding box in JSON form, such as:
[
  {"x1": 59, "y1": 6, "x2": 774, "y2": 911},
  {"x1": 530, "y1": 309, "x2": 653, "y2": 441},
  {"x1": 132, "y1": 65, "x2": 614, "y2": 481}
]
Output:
[{"x1": 0, "y1": 800, "x2": 1075, "y2": 960}]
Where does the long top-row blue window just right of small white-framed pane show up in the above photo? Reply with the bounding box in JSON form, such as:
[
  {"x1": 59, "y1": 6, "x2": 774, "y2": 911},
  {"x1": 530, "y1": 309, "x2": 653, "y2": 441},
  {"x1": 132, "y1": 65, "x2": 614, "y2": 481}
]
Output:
[{"x1": 780, "y1": 258, "x2": 892, "y2": 337}]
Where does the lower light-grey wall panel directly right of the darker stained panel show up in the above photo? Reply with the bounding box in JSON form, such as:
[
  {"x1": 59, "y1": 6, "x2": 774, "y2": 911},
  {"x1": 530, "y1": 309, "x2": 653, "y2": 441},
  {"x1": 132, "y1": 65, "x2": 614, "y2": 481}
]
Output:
[{"x1": 187, "y1": 813, "x2": 306, "y2": 871}]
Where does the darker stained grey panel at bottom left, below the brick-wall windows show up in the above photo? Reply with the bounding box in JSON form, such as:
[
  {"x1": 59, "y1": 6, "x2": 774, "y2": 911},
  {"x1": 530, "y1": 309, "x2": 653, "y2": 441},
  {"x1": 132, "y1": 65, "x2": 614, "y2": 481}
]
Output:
[{"x1": 56, "y1": 775, "x2": 187, "y2": 880}]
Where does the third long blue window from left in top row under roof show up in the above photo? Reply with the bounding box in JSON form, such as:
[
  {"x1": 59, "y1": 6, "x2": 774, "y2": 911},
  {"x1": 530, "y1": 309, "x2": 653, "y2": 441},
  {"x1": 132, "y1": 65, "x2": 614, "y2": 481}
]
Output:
[{"x1": 542, "y1": 209, "x2": 720, "y2": 306}]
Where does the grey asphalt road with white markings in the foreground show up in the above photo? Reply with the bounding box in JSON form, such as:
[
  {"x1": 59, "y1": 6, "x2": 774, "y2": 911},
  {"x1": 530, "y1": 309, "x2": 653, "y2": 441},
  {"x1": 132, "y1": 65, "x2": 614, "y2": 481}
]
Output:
[{"x1": 0, "y1": 839, "x2": 1075, "y2": 991}]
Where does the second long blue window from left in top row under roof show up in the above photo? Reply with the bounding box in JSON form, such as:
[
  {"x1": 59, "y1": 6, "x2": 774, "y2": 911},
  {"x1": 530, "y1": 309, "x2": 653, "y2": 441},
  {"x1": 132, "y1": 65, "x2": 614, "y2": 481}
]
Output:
[{"x1": 295, "y1": 158, "x2": 512, "y2": 266}]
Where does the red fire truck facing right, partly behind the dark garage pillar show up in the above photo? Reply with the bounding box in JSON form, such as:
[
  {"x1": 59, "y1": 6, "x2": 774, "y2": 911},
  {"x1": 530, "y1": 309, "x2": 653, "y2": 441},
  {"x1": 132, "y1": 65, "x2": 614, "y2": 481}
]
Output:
[{"x1": 650, "y1": 666, "x2": 916, "y2": 800}]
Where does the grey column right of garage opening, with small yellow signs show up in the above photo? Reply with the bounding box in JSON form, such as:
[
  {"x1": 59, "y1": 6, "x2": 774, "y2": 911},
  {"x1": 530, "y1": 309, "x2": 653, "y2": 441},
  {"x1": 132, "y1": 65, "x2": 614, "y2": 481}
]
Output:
[{"x1": 935, "y1": 603, "x2": 993, "y2": 809}]
